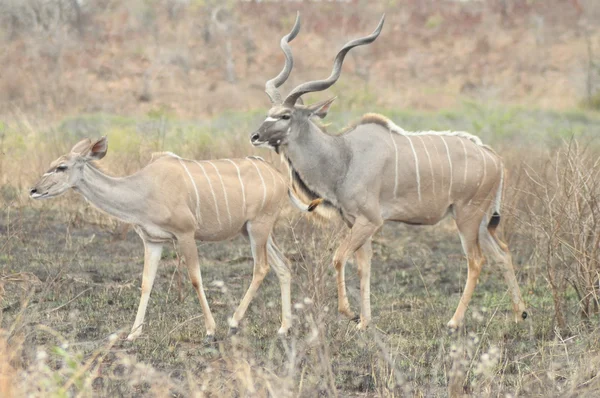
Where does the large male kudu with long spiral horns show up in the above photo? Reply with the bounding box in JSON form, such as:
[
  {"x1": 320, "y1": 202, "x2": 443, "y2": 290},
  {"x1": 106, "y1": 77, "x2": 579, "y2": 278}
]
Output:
[{"x1": 250, "y1": 18, "x2": 527, "y2": 329}]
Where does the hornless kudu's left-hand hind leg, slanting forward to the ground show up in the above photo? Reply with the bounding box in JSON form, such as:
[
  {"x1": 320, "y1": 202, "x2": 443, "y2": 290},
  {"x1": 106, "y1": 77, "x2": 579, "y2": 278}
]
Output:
[{"x1": 229, "y1": 221, "x2": 272, "y2": 331}]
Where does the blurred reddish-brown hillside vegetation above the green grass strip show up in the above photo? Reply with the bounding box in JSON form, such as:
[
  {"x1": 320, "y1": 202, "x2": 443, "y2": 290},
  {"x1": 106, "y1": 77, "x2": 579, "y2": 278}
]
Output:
[{"x1": 0, "y1": 0, "x2": 600, "y2": 121}]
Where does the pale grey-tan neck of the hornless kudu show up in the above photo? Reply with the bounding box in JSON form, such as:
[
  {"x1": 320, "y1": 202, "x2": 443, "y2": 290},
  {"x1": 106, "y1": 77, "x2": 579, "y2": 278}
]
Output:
[{"x1": 74, "y1": 164, "x2": 146, "y2": 224}]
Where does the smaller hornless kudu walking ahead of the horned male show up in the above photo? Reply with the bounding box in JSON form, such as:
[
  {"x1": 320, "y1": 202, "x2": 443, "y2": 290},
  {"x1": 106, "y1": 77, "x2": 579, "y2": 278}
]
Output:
[{"x1": 30, "y1": 137, "x2": 292, "y2": 340}]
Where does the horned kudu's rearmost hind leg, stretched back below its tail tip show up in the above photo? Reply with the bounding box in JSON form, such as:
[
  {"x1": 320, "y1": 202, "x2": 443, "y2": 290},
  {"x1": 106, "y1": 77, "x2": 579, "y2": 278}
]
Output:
[{"x1": 479, "y1": 227, "x2": 527, "y2": 322}]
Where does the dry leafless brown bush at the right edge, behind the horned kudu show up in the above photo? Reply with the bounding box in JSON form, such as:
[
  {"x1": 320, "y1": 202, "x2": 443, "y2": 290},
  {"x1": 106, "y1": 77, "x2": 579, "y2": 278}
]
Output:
[{"x1": 519, "y1": 140, "x2": 600, "y2": 331}]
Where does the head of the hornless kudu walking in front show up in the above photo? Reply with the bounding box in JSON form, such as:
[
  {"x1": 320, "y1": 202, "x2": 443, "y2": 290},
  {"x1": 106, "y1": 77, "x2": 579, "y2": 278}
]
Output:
[{"x1": 29, "y1": 137, "x2": 108, "y2": 199}]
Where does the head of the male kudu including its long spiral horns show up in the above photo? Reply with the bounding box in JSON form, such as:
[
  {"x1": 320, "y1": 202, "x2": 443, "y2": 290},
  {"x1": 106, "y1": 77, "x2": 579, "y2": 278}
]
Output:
[{"x1": 250, "y1": 15, "x2": 385, "y2": 151}]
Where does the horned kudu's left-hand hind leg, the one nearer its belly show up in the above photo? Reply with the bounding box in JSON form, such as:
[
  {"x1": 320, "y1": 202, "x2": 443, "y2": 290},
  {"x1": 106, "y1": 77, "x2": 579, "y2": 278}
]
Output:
[{"x1": 448, "y1": 219, "x2": 485, "y2": 329}]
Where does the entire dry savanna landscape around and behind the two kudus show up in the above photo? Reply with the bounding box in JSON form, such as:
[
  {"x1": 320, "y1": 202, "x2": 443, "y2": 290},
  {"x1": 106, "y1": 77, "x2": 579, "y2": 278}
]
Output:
[{"x1": 0, "y1": 0, "x2": 600, "y2": 397}]
